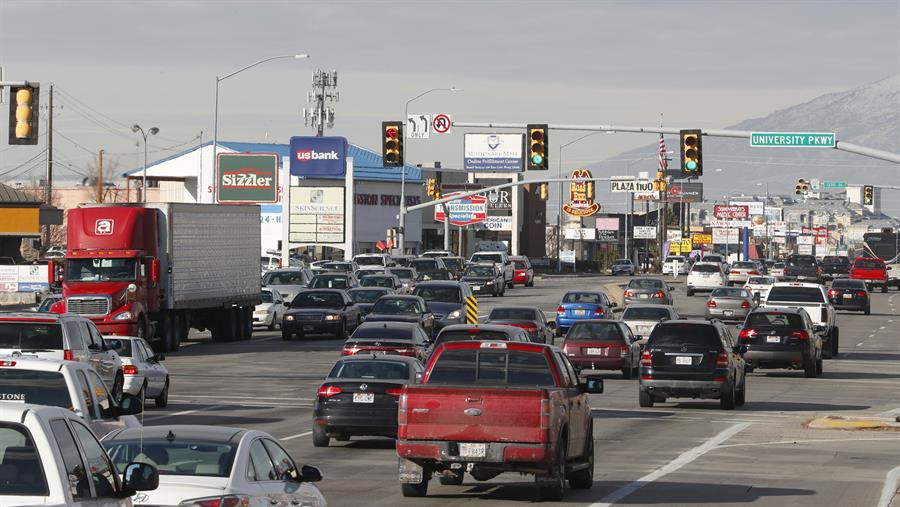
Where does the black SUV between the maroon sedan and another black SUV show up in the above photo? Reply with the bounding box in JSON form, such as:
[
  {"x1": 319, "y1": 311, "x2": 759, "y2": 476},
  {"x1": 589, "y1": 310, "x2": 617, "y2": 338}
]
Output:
[{"x1": 638, "y1": 320, "x2": 747, "y2": 410}]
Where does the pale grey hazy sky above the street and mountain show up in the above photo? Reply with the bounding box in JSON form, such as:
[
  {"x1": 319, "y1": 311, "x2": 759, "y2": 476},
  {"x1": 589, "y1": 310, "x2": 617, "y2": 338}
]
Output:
[{"x1": 0, "y1": 0, "x2": 900, "y2": 192}]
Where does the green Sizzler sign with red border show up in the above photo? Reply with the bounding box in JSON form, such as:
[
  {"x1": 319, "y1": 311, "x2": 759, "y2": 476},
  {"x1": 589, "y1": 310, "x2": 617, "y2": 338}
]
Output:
[{"x1": 216, "y1": 153, "x2": 278, "y2": 204}]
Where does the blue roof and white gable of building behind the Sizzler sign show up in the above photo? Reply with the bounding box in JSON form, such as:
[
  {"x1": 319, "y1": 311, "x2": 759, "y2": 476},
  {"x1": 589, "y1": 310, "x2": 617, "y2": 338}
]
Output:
[{"x1": 122, "y1": 141, "x2": 423, "y2": 183}]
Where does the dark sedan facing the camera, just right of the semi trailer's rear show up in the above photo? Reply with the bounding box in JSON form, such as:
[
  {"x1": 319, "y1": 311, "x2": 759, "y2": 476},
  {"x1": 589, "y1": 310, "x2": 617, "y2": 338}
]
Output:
[{"x1": 281, "y1": 289, "x2": 362, "y2": 340}]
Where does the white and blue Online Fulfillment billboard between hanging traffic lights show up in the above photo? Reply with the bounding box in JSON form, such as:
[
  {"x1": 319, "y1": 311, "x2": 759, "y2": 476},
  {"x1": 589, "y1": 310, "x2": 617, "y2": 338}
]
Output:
[{"x1": 463, "y1": 134, "x2": 525, "y2": 172}]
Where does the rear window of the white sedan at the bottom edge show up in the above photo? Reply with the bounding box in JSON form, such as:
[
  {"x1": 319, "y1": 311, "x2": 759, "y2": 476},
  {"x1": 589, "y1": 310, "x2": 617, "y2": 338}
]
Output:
[{"x1": 103, "y1": 438, "x2": 237, "y2": 477}]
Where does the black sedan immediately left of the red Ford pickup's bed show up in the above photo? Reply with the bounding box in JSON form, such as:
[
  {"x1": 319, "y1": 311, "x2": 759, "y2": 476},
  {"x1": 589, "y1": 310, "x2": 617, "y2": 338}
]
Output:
[{"x1": 312, "y1": 354, "x2": 425, "y2": 447}]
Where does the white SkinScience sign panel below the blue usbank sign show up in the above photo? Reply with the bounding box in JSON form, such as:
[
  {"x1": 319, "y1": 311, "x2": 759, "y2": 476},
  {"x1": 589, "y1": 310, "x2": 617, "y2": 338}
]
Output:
[{"x1": 288, "y1": 187, "x2": 345, "y2": 244}]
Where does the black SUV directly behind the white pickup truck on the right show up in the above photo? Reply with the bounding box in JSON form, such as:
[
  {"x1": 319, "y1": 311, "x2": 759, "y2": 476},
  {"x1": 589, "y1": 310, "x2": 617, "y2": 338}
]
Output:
[{"x1": 738, "y1": 308, "x2": 824, "y2": 378}]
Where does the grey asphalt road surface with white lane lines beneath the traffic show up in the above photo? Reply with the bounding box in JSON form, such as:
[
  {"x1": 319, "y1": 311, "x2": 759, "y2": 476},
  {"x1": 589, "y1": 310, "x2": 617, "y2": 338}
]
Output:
[{"x1": 144, "y1": 277, "x2": 900, "y2": 507}]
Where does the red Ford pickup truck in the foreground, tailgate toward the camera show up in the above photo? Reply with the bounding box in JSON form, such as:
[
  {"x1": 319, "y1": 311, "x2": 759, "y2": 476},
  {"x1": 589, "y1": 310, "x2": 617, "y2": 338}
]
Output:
[{"x1": 397, "y1": 341, "x2": 603, "y2": 500}]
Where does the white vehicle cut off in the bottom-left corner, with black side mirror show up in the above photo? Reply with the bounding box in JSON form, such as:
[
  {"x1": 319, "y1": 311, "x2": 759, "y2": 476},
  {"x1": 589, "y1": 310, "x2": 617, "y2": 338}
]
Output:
[{"x1": 0, "y1": 401, "x2": 159, "y2": 507}]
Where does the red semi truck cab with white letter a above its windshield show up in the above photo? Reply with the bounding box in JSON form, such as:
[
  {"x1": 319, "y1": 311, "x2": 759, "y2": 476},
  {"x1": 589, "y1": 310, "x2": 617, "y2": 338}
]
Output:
[{"x1": 50, "y1": 206, "x2": 164, "y2": 338}]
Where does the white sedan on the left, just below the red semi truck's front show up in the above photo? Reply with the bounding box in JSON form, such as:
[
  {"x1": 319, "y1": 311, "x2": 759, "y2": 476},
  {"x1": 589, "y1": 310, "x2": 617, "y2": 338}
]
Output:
[{"x1": 103, "y1": 336, "x2": 169, "y2": 408}]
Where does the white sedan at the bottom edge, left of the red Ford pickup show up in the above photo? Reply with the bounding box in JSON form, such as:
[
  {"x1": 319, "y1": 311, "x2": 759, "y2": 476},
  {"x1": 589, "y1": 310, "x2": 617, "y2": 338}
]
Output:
[{"x1": 103, "y1": 425, "x2": 326, "y2": 507}]
